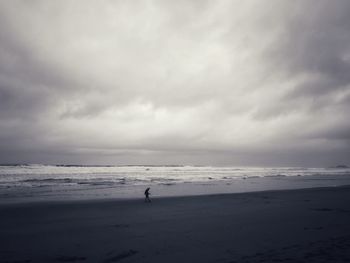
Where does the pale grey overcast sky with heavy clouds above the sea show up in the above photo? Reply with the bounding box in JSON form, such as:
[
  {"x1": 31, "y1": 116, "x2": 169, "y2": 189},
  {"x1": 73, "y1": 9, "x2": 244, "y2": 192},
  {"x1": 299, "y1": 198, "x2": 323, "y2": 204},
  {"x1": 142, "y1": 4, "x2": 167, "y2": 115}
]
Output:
[{"x1": 0, "y1": 0, "x2": 350, "y2": 167}]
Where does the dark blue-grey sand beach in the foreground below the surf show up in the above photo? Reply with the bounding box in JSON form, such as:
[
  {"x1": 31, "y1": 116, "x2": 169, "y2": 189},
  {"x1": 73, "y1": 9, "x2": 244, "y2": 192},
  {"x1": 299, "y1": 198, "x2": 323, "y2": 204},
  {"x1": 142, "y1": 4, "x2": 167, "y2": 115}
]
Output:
[{"x1": 0, "y1": 187, "x2": 350, "y2": 263}]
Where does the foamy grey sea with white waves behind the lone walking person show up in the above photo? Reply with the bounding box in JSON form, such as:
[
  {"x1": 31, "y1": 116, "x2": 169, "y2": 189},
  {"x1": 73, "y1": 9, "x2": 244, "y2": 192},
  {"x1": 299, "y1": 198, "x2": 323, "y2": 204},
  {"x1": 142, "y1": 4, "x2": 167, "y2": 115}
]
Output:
[{"x1": 0, "y1": 165, "x2": 350, "y2": 202}]
